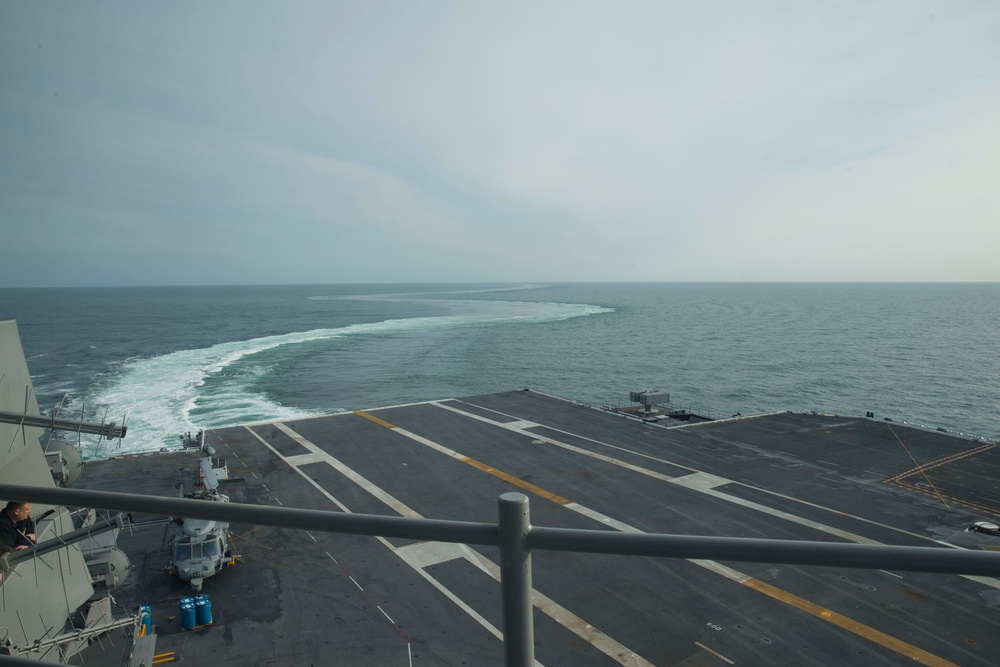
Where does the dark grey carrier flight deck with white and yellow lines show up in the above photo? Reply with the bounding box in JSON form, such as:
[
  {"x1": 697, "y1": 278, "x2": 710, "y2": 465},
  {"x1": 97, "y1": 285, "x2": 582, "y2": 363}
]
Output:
[{"x1": 76, "y1": 391, "x2": 1000, "y2": 666}]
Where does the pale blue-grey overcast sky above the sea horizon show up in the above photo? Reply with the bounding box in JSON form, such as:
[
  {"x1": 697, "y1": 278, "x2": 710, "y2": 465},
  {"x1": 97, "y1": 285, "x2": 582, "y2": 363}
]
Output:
[{"x1": 0, "y1": 0, "x2": 1000, "y2": 287}]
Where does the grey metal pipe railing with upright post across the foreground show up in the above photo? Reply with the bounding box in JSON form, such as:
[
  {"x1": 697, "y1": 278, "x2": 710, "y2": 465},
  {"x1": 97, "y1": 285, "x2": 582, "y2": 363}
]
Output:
[{"x1": 0, "y1": 484, "x2": 1000, "y2": 667}]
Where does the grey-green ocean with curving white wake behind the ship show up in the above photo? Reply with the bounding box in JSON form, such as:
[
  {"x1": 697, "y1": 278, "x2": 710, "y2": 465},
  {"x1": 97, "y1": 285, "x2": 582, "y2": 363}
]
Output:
[{"x1": 0, "y1": 283, "x2": 1000, "y2": 456}]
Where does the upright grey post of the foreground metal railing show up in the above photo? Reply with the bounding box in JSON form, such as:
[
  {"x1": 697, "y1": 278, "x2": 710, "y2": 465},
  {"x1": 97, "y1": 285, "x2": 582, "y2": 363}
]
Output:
[{"x1": 499, "y1": 492, "x2": 535, "y2": 667}]
